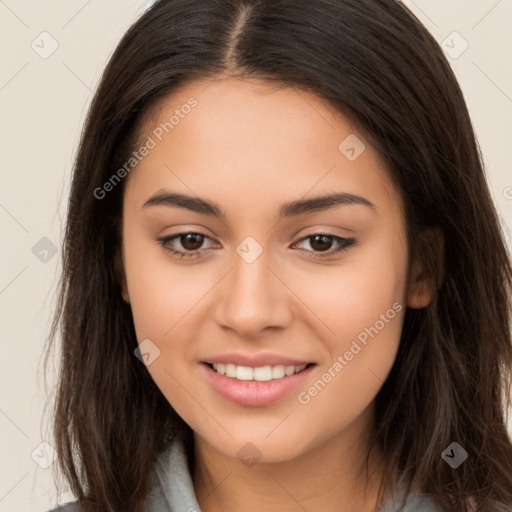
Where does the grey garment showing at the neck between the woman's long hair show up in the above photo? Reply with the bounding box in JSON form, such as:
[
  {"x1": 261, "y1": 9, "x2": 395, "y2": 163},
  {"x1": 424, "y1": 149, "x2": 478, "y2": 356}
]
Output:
[{"x1": 48, "y1": 439, "x2": 439, "y2": 512}]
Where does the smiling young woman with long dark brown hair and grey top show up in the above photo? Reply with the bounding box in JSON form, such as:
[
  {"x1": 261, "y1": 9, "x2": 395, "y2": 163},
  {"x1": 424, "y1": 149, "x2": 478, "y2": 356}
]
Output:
[{"x1": 43, "y1": 0, "x2": 512, "y2": 512}]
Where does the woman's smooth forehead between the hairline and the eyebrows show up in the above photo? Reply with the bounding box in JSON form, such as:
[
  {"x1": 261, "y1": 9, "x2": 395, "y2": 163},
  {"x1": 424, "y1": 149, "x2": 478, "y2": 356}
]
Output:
[{"x1": 127, "y1": 78, "x2": 398, "y2": 217}]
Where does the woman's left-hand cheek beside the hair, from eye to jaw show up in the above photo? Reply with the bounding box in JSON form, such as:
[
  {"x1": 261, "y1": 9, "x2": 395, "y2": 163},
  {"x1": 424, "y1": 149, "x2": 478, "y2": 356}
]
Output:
[{"x1": 124, "y1": 231, "x2": 207, "y2": 419}]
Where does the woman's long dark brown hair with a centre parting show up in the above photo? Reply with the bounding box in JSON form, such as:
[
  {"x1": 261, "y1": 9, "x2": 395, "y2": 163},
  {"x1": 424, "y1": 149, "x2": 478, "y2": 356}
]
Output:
[{"x1": 45, "y1": 0, "x2": 512, "y2": 512}]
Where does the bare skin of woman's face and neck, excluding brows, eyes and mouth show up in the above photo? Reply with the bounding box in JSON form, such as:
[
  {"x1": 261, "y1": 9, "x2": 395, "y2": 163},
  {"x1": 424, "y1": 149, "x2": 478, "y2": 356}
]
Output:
[{"x1": 118, "y1": 77, "x2": 431, "y2": 512}]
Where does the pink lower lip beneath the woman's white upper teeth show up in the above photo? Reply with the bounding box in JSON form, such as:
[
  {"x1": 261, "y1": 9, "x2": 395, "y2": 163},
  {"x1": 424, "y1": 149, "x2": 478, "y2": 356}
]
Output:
[{"x1": 201, "y1": 363, "x2": 315, "y2": 407}]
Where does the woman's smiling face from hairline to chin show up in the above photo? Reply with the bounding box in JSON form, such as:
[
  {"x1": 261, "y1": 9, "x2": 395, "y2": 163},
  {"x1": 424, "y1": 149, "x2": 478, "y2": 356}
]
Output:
[{"x1": 118, "y1": 78, "x2": 422, "y2": 461}]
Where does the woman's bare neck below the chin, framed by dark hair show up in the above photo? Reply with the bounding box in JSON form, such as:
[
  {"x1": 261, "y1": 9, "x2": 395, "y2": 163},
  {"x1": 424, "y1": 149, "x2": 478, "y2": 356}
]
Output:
[{"x1": 192, "y1": 408, "x2": 388, "y2": 512}]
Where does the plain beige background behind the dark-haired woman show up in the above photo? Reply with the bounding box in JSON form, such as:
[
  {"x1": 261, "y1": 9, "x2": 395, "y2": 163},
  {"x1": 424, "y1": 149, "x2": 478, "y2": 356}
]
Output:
[{"x1": 0, "y1": 0, "x2": 512, "y2": 512}]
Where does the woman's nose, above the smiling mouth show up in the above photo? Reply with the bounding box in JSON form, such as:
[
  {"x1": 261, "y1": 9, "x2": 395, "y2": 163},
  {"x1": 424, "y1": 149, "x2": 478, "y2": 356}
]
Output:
[{"x1": 215, "y1": 252, "x2": 293, "y2": 339}]
